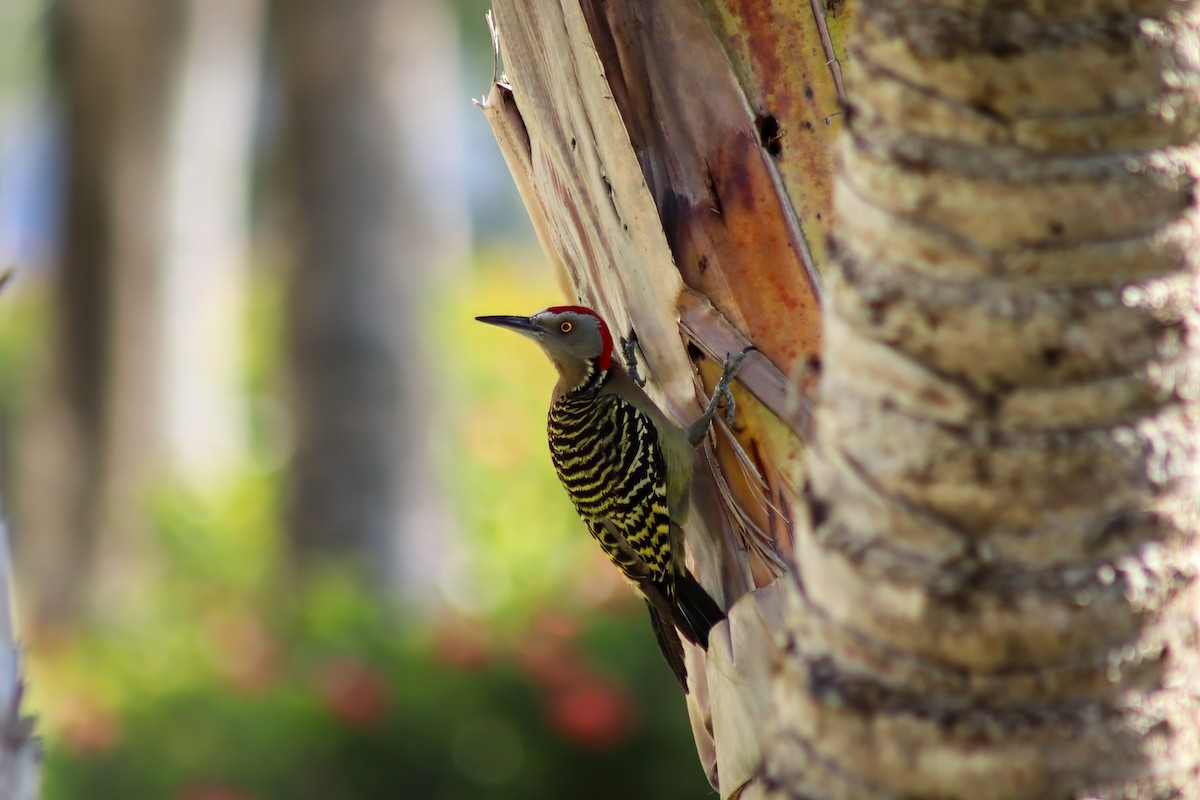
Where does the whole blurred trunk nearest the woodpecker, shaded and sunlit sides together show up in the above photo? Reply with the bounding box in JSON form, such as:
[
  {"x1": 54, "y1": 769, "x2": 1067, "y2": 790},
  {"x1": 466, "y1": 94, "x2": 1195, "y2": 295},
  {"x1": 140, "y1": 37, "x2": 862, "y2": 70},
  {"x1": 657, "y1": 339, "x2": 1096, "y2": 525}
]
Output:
[{"x1": 275, "y1": 0, "x2": 469, "y2": 589}]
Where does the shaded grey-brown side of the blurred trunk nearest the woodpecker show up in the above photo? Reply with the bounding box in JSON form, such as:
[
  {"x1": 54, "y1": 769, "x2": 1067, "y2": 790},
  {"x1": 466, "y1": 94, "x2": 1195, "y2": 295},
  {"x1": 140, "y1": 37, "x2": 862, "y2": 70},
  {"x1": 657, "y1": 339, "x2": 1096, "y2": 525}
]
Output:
[{"x1": 278, "y1": 0, "x2": 413, "y2": 585}]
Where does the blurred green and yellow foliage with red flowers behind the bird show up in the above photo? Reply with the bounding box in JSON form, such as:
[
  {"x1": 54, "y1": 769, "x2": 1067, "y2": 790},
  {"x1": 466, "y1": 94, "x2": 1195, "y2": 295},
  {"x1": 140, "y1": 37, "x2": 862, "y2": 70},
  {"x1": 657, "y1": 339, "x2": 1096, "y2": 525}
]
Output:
[{"x1": 14, "y1": 263, "x2": 712, "y2": 800}]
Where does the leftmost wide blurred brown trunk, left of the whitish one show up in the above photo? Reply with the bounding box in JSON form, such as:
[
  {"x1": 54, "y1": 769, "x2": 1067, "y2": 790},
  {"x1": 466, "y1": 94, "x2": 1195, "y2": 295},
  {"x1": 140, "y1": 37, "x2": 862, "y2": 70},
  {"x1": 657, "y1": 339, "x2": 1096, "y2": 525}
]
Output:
[{"x1": 17, "y1": 0, "x2": 179, "y2": 624}]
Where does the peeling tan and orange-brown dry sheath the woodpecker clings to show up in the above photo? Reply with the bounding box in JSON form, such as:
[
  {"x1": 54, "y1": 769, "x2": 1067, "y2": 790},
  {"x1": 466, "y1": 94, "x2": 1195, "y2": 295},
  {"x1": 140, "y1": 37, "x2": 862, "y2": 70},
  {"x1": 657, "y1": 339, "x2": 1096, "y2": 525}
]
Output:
[{"x1": 482, "y1": 0, "x2": 838, "y2": 796}]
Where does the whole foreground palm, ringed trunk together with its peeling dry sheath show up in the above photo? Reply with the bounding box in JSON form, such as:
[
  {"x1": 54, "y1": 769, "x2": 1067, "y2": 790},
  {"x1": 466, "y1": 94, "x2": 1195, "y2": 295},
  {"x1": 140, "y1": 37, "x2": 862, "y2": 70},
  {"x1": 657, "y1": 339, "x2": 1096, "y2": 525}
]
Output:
[{"x1": 484, "y1": 0, "x2": 1200, "y2": 799}]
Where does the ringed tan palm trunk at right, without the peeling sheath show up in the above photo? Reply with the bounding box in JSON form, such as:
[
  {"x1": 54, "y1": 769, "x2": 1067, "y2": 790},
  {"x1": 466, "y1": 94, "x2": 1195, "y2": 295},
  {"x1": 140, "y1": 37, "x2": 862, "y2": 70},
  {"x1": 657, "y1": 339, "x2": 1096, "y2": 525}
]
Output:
[{"x1": 767, "y1": 0, "x2": 1200, "y2": 800}]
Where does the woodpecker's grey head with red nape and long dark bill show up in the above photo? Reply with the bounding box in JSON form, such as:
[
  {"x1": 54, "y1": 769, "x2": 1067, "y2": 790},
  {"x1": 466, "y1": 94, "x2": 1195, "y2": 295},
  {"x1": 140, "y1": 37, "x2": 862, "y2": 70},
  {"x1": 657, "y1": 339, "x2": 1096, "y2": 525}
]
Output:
[{"x1": 475, "y1": 306, "x2": 612, "y2": 389}]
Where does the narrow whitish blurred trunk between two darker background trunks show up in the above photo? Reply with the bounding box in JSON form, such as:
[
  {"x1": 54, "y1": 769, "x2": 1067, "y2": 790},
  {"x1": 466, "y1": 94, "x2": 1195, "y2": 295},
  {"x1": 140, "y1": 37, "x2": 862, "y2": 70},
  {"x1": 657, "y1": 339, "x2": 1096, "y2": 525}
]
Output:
[{"x1": 162, "y1": 0, "x2": 265, "y2": 488}]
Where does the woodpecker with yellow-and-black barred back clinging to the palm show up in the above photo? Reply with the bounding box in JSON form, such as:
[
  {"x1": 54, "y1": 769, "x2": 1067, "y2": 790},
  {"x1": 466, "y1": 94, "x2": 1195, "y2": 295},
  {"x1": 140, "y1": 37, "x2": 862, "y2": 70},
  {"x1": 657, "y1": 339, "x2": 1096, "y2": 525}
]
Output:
[{"x1": 475, "y1": 306, "x2": 746, "y2": 692}]
